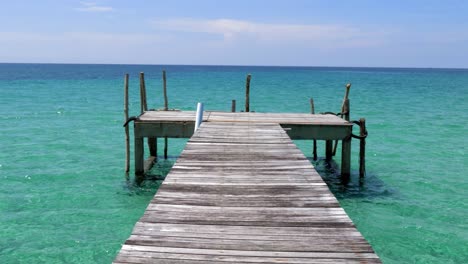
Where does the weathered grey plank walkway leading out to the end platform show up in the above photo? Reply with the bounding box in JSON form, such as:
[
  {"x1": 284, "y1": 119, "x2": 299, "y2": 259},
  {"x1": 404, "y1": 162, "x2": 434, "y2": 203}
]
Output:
[{"x1": 115, "y1": 120, "x2": 380, "y2": 263}]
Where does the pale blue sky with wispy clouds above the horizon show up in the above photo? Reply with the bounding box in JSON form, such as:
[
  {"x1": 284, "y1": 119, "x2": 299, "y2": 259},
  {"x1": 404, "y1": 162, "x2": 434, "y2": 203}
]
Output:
[{"x1": 0, "y1": 0, "x2": 468, "y2": 68}]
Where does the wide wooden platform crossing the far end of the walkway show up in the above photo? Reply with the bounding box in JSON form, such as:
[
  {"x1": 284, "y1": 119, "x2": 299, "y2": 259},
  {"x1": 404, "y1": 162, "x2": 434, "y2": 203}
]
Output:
[{"x1": 134, "y1": 111, "x2": 353, "y2": 177}]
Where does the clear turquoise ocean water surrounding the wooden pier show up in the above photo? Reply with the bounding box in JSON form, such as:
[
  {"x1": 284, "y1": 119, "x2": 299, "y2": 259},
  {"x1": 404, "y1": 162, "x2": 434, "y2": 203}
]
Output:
[{"x1": 0, "y1": 64, "x2": 468, "y2": 263}]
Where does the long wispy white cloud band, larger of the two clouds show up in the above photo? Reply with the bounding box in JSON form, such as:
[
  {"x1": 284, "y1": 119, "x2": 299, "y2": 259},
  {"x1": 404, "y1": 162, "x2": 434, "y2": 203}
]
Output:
[{"x1": 151, "y1": 18, "x2": 383, "y2": 46}]
